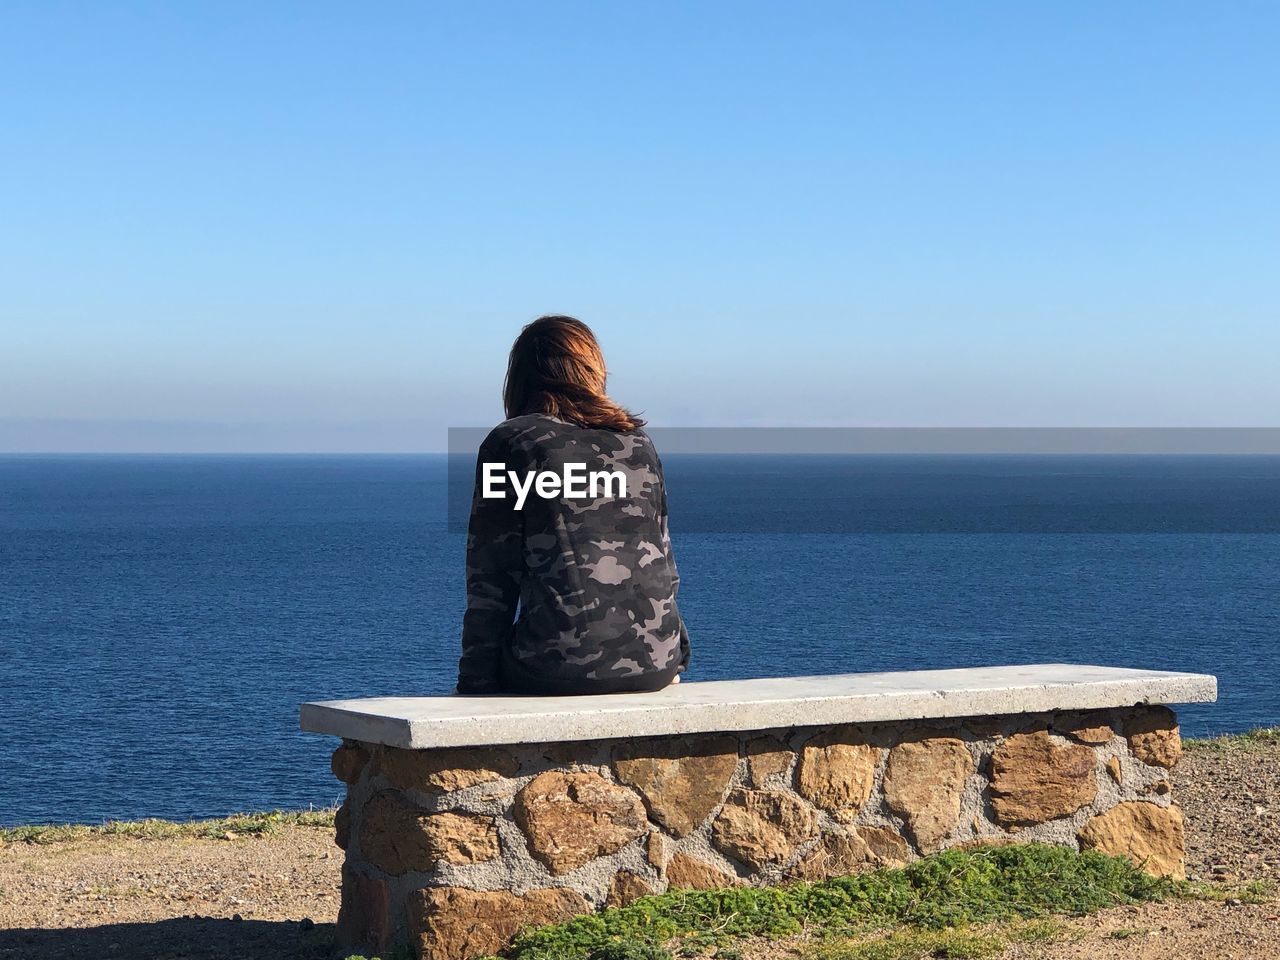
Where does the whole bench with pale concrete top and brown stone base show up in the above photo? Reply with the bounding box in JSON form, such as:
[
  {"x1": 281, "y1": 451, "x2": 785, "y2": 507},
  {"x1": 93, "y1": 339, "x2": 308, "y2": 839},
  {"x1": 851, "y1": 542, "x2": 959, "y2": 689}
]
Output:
[{"x1": 301, "y1": 664, "x2": 1216, "y2": 960}]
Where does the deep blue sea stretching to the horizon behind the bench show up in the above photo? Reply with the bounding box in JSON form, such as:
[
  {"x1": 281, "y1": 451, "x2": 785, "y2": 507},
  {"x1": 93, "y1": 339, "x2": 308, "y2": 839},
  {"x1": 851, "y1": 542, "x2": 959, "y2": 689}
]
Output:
[{"x1": 0, "y1": 456, "x2": 1280, "y2": 826}]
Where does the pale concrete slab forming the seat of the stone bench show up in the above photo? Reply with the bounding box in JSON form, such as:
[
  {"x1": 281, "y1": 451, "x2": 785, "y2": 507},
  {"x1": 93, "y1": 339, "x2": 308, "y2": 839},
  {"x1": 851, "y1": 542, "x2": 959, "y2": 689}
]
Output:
[{"x1": 301, "y1": 663, "x2": 1217, "y2": 749}]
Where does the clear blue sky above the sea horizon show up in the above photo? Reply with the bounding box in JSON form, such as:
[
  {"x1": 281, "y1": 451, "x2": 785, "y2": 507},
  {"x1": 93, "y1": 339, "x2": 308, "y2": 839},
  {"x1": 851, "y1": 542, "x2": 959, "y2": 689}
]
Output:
[{"x1": 0, "y1": 3, "x2": 1280, "y2": 449}]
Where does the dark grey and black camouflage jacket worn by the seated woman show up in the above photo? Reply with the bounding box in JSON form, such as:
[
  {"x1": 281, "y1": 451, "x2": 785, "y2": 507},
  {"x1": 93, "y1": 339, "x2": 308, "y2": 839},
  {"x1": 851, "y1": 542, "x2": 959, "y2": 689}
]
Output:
[{"x1": 458, "y1": 415, "x2": 689, "y2": 692}]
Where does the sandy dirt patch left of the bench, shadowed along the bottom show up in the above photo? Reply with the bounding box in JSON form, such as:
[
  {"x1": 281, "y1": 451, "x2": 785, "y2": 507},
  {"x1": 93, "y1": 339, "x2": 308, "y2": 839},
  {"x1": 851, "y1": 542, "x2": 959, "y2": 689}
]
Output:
[{"x1": 0, "y1": 827, "x2": 342, "y2": 960}]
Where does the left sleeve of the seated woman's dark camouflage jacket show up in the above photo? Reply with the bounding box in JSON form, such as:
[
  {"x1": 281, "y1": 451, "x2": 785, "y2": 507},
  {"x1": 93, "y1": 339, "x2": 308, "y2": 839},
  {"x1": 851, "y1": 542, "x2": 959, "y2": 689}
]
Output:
[{"x1": 458, "y1": 434, "x2": 525, "y2": 694}]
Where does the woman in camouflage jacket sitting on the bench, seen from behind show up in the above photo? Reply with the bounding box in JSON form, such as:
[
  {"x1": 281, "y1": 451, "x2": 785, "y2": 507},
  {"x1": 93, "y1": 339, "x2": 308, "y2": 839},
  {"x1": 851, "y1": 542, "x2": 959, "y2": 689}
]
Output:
[{"x1": 458, "y1": 316, "x2": 689, "y2": 695}]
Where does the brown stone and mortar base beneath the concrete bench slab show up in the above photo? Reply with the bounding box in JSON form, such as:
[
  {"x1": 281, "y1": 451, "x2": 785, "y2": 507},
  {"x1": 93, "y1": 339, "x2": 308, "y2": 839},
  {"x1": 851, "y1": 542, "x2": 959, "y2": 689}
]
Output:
[{"x1": 333, "y1": 707, "x2": 1183, "y2": 960}]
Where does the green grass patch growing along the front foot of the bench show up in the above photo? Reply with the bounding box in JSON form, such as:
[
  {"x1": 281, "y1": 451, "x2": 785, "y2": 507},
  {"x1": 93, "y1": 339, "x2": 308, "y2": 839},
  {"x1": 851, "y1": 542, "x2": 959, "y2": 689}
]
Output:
[{"x1": 494, "y1": 844, "x2": 1181, "y2": 960}]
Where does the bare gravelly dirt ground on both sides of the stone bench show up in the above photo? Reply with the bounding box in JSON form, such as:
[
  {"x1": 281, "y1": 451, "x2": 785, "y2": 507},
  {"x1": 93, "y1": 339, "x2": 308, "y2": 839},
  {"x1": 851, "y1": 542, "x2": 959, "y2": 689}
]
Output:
[{"x1": 0, "y1": 744, "x2": 1280, "y2": 960}]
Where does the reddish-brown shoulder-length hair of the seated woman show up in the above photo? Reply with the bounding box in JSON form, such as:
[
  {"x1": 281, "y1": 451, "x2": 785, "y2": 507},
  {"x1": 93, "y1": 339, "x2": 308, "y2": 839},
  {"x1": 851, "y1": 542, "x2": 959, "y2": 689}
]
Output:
[{"x1": 502, "y1": 316, "x2": 644, "y2": 433}]
